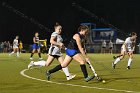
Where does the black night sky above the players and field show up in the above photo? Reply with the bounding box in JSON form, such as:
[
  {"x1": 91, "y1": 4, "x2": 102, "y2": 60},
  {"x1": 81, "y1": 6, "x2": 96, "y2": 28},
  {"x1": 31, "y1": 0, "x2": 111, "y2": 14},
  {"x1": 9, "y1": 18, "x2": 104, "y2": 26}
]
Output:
[{"x1": 0, "y1": 0, "x2": 140, "y2": 43}]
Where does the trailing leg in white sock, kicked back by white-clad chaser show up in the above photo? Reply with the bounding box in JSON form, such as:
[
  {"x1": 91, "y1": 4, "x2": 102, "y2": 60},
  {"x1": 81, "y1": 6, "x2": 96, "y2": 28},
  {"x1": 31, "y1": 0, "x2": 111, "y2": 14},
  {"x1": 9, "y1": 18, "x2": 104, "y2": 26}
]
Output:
[{"x1": 28, "y1": 55, "x2": 55, "y2": 68}]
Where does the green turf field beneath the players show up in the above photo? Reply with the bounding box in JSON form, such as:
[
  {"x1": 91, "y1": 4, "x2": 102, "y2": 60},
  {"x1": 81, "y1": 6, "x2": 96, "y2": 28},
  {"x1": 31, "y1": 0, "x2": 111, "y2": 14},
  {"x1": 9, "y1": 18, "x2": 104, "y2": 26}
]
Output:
[{"x1": 0, "y1": 53, "x2": 140, "y2": 93}]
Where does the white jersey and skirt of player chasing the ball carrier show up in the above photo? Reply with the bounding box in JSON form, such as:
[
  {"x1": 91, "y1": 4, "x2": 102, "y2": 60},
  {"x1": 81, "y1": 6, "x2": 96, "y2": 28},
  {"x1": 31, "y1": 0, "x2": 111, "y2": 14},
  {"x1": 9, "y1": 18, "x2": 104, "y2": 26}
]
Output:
[{"x1": 48, "y1": 32, "x2": 63, "y2": 56}]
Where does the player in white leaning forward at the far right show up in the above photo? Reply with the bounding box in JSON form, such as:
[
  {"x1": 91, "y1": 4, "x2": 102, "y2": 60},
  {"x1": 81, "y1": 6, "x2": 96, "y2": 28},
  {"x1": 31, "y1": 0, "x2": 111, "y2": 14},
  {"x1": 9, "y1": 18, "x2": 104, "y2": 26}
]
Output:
[{"x1": 112, "y1": 32, "x2": 137, "y2": 69}]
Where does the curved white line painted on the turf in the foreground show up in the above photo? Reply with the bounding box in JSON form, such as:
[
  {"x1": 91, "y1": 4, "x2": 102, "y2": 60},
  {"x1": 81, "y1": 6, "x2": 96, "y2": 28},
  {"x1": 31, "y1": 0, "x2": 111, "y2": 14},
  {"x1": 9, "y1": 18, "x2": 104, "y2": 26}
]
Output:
[{"x1": 20, "y1": 69, "x2": 140, "y2": 93}]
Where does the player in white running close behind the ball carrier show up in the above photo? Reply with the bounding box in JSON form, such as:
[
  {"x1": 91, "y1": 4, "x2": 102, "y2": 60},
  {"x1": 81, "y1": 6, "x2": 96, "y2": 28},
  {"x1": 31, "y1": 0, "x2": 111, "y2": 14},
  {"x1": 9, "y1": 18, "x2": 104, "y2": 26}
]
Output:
[{"x1": 28, "y1": 23, "x2": 75, "y2": 80}]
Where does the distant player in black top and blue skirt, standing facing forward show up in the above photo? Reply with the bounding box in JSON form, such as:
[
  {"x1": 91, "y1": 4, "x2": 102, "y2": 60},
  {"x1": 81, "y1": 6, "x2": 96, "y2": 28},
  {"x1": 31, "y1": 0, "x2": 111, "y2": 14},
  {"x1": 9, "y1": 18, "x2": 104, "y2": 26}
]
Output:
[{"x1": 30, "y1": 32, "x2": 42, "y2": 60}]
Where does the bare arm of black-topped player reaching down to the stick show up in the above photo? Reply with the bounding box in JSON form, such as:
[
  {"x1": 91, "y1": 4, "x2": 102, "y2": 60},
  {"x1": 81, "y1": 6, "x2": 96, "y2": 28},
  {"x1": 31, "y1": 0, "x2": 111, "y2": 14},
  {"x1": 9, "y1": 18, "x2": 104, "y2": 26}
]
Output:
[{"x1": 73, "y1": 34, "x2": 88, "y2": 59}]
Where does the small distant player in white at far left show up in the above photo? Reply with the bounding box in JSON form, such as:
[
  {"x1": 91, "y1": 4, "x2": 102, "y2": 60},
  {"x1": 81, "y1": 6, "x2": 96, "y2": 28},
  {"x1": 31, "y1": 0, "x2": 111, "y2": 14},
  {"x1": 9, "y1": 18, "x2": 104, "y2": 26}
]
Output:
[{"x1": 9, "y1": 36, "x2": 19, "y2": 57}]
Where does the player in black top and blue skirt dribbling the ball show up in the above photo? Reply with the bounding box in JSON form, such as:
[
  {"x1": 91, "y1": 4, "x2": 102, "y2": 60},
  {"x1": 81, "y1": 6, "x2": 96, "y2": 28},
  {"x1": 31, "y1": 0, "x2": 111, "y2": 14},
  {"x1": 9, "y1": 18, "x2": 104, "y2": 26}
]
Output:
[{"x1": 46, "y1": 26, "x2": 94, "y2": 82}]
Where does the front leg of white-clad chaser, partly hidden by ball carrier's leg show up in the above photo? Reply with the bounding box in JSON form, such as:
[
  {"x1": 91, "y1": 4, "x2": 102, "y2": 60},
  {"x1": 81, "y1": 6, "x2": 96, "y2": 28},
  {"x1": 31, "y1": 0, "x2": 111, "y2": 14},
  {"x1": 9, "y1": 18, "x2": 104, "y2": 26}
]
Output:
[{"x1": 58, "y1": 56, "x2": 75, "y2": 80}]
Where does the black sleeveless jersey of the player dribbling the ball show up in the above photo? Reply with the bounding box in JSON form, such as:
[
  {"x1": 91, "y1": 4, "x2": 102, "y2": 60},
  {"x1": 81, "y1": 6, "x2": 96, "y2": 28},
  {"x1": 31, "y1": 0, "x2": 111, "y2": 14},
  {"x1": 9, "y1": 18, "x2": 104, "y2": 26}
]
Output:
[{"x1": 67, "y1": 33, "x2": 85, "y2": 51}]
